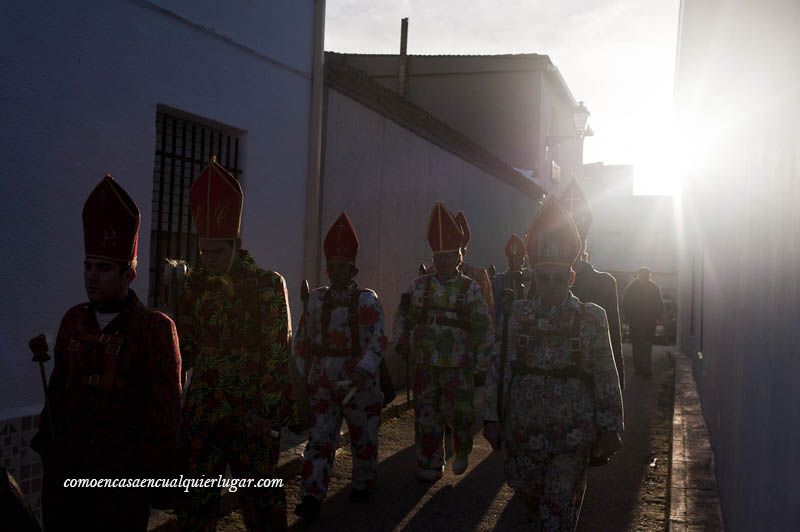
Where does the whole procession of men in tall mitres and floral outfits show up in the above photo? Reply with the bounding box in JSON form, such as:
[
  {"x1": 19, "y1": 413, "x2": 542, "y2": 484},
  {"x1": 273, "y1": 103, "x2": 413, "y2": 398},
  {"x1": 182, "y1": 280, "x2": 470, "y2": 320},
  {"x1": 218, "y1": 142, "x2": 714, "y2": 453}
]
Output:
[{"x1": 20, "y1": 159, "x2": 676, "y2": 531}]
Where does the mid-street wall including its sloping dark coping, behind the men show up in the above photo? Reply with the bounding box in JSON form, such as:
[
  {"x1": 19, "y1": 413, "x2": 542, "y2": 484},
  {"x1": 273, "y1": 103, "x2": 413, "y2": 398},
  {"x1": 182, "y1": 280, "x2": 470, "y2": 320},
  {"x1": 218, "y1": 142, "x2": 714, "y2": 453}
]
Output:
[{"x1": 318, "y1": 63, "x2": 543, "y2": 383}]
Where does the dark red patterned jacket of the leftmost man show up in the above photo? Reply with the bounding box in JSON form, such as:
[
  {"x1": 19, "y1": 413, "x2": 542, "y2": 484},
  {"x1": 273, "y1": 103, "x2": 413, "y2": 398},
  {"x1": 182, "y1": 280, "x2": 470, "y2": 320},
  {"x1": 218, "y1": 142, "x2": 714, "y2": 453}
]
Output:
[{"x1": 32, "y1": 291, "x2": 181, "y2": 477}]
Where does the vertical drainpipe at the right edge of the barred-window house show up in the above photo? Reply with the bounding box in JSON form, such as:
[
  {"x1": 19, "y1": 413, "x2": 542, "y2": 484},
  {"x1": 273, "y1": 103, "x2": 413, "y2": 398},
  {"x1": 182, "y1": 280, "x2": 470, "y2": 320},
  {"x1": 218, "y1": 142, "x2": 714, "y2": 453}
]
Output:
[{"x1": 303, "y1": 0, "x2": 325, "y2": 286}]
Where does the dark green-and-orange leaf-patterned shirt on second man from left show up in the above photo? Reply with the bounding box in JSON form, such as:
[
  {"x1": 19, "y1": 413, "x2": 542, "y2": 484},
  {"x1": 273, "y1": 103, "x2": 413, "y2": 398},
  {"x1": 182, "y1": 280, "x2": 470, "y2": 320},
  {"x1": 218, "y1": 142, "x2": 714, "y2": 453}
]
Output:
[{"x1": 178, "y1": 250, "x2": 291, "y2": 422}]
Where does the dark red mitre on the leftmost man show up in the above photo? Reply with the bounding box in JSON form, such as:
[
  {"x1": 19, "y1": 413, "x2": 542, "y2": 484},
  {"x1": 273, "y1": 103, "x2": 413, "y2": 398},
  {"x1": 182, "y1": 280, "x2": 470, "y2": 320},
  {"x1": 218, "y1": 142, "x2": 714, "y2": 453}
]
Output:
[{"x1": 83, "y1": 175, "x2": 141, "y2": 268}]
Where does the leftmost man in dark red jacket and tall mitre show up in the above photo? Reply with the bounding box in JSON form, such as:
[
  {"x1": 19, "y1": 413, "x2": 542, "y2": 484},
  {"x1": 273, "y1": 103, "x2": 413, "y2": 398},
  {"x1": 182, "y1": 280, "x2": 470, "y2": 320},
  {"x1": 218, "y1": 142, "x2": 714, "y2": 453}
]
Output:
[{"x1": 31, "y1": 176, "x2": 181, "y2": 532}]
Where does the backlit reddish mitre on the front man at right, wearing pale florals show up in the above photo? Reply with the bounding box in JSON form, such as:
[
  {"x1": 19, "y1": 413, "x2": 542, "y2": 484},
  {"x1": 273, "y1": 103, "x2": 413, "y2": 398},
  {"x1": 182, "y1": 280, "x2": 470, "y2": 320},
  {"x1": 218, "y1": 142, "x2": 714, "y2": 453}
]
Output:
[{"x1": 525, "y1": 199, "x2": 582, "y2": 266}]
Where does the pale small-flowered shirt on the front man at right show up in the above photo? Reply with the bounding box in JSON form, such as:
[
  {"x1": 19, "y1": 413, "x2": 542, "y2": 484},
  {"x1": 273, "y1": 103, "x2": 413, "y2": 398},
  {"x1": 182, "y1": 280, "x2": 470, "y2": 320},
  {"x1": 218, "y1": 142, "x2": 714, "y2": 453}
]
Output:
[{"x1": 483, "y1": 294, "x2": 624, "y2": 452}]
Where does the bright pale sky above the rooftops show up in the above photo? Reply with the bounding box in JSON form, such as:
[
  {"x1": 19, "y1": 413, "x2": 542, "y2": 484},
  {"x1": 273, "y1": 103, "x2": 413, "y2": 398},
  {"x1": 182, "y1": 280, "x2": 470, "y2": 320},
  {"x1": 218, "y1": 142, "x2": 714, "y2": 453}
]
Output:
[{"x1": 325, "y1": 0, "x2": 679, "y2": 194}]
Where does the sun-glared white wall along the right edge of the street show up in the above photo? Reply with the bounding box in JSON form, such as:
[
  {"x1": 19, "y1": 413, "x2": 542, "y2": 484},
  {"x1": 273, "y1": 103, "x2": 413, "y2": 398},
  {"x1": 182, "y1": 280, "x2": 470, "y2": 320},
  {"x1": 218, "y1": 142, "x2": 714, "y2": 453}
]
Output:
[{"x1": 676, "y1": 0, "x2": 800, "y2": 532}]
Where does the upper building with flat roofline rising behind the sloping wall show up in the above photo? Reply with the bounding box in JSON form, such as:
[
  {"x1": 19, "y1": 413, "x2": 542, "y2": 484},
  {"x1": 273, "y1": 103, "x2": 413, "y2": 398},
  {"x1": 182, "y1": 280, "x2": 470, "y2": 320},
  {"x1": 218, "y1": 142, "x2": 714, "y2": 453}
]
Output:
[{"x1": 326, "y1": 52, "x2": 592, "y2": 193}]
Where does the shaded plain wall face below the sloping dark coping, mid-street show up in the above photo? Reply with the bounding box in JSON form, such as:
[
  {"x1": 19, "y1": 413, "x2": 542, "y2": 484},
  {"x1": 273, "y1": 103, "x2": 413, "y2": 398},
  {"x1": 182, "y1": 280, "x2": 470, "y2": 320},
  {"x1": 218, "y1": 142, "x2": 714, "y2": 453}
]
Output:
[{"x1": 322, "y1": 90, "x2": 538, "y2": 382}]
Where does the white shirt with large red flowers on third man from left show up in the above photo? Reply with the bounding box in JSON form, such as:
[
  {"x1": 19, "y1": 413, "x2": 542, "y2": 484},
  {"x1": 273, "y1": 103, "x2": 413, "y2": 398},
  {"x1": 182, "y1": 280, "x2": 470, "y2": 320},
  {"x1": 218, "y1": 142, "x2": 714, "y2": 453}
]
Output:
[{"x1": 294, "y1": 282, "x2": 388, "y2": 379}]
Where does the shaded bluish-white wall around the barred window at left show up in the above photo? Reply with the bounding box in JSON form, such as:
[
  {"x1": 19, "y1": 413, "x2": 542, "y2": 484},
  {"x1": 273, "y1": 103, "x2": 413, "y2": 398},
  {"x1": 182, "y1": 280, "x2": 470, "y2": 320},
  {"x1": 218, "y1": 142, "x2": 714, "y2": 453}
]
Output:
[{"x1": 0, "y1": 0, "x2": 313, "y2": 418}]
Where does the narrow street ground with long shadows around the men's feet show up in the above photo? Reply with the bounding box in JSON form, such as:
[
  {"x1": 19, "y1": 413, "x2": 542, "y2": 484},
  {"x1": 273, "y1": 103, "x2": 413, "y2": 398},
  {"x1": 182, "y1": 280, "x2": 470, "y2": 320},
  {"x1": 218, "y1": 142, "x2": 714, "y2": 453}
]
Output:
[{"x1": 218, "y1": 344, "x2": 673, "y2": 532}]
